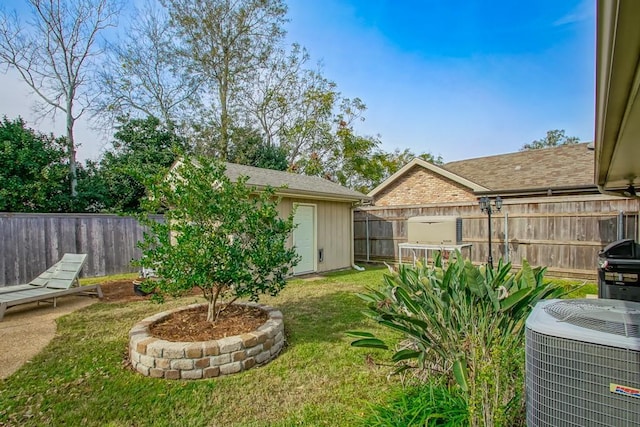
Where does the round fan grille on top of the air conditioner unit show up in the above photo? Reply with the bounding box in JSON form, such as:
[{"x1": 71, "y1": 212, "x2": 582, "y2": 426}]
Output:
[{"x1": 544, "y1": 300, "x2": 640, "y2": 338}]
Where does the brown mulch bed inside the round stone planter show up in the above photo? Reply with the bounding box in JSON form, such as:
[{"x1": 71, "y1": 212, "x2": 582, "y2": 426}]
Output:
[{"x1": 149, "y1": 305, "x2": 268, "y2": 342}]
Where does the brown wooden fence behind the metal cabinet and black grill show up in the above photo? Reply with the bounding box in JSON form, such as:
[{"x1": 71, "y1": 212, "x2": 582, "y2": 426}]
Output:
[{"x1": 354, "y1": 195, "x2": 638, "y2": 279}]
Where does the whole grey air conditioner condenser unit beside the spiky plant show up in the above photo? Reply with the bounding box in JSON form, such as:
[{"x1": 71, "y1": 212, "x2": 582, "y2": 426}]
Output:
[{"x1": 525, "y1": 299, "x2": 640, "y2": 427}]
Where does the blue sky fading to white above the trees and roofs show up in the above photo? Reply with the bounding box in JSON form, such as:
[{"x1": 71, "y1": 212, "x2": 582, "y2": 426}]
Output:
[{"x1": 0, "y1": 0, "x2": 595, "y2": 162}]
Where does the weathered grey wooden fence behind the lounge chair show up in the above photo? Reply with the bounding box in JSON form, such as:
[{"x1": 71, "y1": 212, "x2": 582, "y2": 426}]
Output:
[{"x1": 0, "y1": 213, "x2": 162, "y2": 286}]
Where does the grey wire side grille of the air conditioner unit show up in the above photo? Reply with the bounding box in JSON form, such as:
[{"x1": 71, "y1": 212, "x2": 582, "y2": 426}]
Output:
[{"x1": 526, "y1": 329, "x2": 640, "y2": 427}]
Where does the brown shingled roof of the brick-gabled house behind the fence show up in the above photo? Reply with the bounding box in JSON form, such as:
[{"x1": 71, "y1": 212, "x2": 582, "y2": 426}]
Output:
[{"x1": 443, "y1": 143, "x2": 595, "y2": 191}]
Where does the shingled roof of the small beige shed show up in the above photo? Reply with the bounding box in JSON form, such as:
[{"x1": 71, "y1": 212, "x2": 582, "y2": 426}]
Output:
[{"x1": 225, "y1": 163, "x2": 370, "y2": 201}]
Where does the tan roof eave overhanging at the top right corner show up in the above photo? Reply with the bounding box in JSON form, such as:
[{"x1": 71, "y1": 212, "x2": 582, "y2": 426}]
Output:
[{"x1": 594, "y1": 0, "x2": 640, "y2": 194}]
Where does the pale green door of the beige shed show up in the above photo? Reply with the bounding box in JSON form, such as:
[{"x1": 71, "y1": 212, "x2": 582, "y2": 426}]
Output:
[{"x1": 293, "y1": 205, "x2": 316, "y2": 274}]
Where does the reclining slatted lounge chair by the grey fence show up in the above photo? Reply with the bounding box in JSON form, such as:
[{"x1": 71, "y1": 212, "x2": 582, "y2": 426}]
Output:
[{"x1": 0, "y1": 254, "x2": 102, "y2": 321}]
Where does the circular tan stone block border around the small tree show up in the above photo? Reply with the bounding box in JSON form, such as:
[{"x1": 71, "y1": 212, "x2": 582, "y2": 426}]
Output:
[{"x1": 129, "y1": 303, "x2": 284, "y2": 380}]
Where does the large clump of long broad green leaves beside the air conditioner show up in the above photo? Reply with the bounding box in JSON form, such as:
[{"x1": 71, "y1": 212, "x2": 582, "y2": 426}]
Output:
[{"x1": 350, "y1": 252, "x2": 564, "y2": 426}]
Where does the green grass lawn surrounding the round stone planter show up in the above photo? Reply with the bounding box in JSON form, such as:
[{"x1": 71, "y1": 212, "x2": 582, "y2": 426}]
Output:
[{"x1": 0, "y1": 269, "x2": 399, "y2": 426}]
